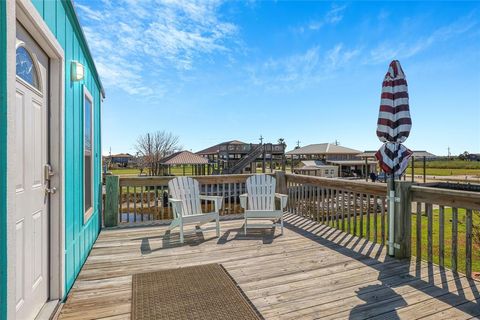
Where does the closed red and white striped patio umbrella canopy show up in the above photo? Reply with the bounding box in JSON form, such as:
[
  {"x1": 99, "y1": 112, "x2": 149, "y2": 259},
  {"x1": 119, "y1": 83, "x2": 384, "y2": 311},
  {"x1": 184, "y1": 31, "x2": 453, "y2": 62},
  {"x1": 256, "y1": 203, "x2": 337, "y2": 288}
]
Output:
[{"x1": 375, "y1": 60, "x2": 412, "y2": 175}]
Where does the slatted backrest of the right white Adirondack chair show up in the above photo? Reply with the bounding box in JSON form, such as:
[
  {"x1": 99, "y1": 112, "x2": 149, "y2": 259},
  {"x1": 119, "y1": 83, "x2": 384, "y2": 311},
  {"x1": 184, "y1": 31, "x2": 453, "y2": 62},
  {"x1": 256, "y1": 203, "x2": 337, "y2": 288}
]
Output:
[{"x1": 246, "y1": 174, "x2": 276, "y2": 211}]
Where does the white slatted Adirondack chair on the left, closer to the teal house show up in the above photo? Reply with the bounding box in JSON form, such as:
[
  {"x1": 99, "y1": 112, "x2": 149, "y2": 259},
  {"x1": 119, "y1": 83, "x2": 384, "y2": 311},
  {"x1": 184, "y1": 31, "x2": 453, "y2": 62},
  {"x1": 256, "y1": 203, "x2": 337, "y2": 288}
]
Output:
[{"x1": 168, "y1": 177, "x2": 223, "y2": 243}]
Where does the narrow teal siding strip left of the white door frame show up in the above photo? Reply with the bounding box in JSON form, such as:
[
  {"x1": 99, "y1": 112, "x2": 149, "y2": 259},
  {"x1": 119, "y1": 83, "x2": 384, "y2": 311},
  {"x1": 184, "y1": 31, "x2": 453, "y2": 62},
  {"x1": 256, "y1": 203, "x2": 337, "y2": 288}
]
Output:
[{"x1": 0, "y1": 1, "x2": 7, "y2": 319}]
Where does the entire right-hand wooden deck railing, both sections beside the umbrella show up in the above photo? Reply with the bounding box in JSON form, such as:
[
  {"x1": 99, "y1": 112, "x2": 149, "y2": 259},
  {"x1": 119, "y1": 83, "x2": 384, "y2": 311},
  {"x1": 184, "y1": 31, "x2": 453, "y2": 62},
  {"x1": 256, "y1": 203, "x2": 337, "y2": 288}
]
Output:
[{"x1": 286, "y1": 174, "x2": 480, "y2": 277}]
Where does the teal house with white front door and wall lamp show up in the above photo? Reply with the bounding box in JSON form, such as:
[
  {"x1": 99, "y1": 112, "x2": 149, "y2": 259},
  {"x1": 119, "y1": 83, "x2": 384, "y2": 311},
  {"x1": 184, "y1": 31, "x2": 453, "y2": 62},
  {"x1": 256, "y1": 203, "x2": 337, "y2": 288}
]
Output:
[{"x1": 0, "y1": 0, "x2": 104, "y2": 319}]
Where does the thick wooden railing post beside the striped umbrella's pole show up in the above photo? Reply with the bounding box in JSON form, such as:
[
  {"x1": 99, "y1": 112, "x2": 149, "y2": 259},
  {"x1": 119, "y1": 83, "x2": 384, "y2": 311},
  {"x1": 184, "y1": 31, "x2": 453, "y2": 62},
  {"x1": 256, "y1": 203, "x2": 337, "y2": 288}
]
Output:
[{"x1": 394, "y1": 181, "x2": 412, "y2": 259}]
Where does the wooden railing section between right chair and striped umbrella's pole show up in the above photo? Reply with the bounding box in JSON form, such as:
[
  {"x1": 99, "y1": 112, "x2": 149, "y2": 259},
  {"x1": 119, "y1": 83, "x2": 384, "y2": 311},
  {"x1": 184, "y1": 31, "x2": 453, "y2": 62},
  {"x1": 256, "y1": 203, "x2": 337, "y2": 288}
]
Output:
[{"x1": 286, "y1": 174, "x2": 388, "y2": 244}]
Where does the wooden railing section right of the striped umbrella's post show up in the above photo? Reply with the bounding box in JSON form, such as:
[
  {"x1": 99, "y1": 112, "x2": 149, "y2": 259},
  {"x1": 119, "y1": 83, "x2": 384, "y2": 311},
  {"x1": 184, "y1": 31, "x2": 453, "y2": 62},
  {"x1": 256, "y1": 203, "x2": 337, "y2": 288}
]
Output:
[{"x1": 409, "y1": 185, "x2": 480, "y2": 277}]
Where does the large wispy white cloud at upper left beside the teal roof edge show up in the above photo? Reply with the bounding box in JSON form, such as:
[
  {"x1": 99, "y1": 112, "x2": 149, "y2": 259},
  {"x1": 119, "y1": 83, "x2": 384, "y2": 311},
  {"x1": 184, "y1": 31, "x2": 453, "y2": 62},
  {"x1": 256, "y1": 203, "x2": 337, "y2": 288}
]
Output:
[{"x1": 75, "y1": 0, "x2": 237, "y2": 95}]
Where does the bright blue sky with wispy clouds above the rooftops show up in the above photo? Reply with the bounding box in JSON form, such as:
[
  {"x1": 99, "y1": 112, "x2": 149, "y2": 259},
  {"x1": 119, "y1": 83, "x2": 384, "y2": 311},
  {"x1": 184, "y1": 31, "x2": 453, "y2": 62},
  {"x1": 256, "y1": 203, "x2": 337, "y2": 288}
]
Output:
[{"x1": 75, "y1": 0, "x2": 480, "y2": 155}]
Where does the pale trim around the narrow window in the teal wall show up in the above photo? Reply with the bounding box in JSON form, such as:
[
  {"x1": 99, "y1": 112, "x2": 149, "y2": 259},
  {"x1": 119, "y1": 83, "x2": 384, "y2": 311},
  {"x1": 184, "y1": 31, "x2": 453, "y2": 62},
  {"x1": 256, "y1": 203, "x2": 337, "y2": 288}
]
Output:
[{"x1": 82, "y1": 85, "x2": 95, "y2": 224}]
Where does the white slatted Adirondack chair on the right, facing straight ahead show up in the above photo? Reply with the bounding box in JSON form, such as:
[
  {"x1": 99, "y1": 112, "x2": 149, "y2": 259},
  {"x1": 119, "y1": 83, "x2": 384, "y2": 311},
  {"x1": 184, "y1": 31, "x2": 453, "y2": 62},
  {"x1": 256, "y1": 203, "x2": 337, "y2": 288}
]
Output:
[{"x1": 240, "y1": 174, "x2": 288, "y2": 234}]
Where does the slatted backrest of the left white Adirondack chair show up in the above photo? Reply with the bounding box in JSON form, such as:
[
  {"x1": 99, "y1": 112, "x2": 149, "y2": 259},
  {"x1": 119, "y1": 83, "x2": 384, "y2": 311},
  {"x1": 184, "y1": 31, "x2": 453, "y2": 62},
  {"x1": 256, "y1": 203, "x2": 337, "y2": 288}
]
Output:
[{"x1": 168, "y1": 177, "x2": 202, "y2": 216}]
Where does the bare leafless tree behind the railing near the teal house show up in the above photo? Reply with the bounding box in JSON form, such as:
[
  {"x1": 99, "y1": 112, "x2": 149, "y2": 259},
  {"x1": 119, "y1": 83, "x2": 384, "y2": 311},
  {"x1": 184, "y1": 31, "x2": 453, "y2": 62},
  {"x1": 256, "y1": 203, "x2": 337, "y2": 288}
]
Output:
[{"x1": 135, "y1": 131, "x2": 181, "y2": 176}]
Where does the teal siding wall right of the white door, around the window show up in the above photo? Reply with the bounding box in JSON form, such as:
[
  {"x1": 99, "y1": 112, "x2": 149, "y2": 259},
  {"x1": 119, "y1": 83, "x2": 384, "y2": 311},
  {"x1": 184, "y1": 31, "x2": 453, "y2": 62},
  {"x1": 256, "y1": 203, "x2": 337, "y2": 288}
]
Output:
[{"x1": 32, "y1": 0, "x2": 101, "y2": 292}]
